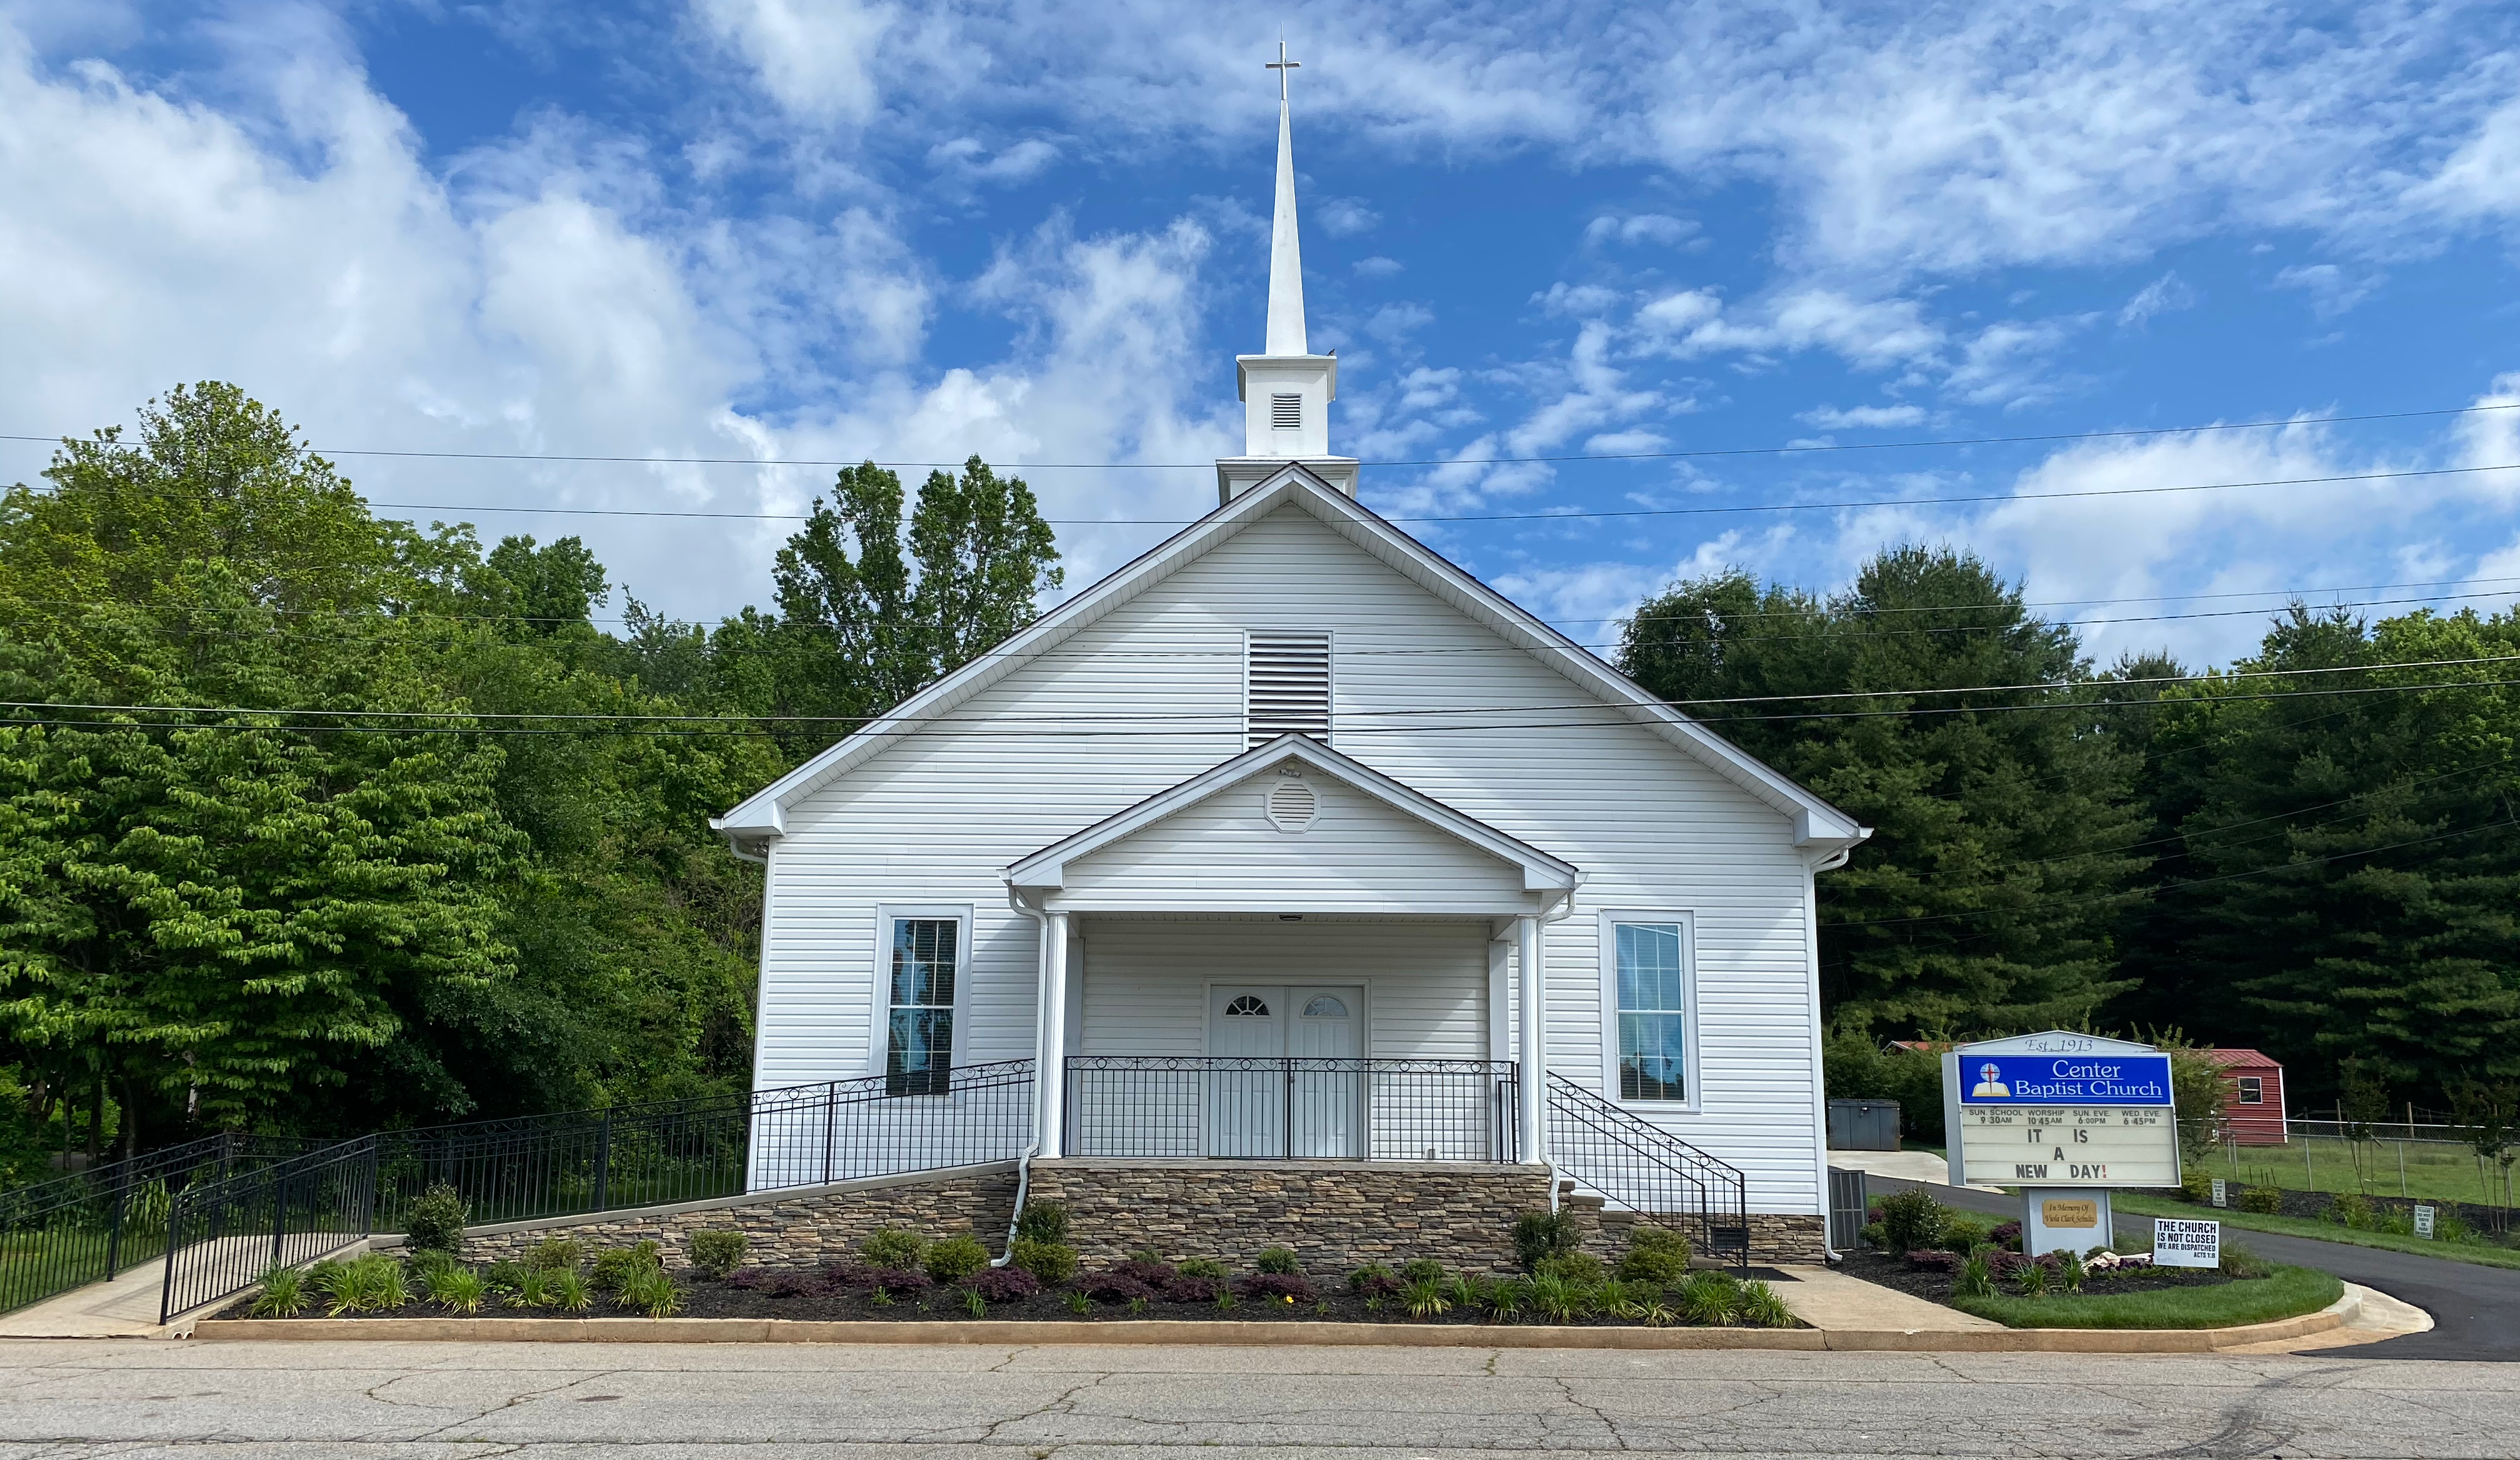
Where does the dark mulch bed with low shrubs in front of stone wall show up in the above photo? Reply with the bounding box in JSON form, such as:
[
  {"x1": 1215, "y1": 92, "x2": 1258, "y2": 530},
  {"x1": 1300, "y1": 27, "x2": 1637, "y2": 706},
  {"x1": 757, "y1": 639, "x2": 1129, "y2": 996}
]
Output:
[{"x1": 217, "y1": 1268, "x2": 1804, "y2": 1329}]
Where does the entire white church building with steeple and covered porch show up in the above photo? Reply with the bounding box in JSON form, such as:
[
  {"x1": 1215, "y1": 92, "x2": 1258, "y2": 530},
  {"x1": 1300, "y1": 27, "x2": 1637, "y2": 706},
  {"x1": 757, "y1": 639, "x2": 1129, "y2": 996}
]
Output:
[{"x1": 713, "y1": 71, "x2": 1868, "y2": 1258}]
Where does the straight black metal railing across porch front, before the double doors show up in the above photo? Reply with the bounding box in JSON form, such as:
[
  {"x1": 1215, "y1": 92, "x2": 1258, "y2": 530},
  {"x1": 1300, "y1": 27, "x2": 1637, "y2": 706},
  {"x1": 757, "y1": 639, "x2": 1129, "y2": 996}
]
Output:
[{"x1": 1064, "y1": 1054, "x2": 1517, "y2": 1162}]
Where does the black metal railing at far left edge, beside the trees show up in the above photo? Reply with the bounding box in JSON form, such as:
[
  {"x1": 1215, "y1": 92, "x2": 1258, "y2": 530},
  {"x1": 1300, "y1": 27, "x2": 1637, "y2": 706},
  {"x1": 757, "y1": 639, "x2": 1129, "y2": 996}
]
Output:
[{"x1": 0, "y1": 1135, "x2": 318, "y2": 1314}]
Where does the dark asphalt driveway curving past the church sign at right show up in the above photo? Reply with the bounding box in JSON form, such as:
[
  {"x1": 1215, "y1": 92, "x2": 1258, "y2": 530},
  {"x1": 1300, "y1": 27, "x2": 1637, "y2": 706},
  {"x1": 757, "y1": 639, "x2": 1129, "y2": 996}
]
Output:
[{"x1": 1865, "y1": 1178, "x2": 2520, "y2": 1364}]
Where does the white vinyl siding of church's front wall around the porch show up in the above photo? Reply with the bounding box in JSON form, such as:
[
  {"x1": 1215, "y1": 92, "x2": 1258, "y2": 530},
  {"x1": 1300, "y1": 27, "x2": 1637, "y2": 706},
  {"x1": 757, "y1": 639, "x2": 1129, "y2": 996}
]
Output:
[{"x1": 759, "y1": 507, "x2": 1822, "y2": 1213}]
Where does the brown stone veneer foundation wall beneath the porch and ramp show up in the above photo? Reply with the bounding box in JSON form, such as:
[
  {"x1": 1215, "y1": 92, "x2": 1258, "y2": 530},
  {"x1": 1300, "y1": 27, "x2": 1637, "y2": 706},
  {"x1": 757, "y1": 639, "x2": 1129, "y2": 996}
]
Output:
[{"x1": 423, "y1": 1160, "x2": 1827, "y2": 1273}]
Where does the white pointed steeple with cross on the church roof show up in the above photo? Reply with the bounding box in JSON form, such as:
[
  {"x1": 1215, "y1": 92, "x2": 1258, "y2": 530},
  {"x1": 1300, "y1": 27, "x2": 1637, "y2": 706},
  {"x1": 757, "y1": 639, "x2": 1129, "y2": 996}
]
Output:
[{"x1": 1217, "y1": 41, "x2": 1356, "y2": 502}]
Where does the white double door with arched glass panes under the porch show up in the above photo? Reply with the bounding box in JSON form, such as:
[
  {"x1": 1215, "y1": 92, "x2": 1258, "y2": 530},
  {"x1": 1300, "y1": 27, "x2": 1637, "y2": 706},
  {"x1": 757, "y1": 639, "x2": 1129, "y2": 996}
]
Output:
[{"x1": 1207, "y1": 983, "x2": 1366, "y2": 1160}]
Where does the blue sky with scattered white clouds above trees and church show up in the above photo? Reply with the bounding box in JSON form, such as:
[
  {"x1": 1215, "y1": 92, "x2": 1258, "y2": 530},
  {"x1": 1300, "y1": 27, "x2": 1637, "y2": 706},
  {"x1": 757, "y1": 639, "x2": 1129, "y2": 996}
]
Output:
[{"x1": 0, "y1": 0, "x2": 2520, "y2": 663}]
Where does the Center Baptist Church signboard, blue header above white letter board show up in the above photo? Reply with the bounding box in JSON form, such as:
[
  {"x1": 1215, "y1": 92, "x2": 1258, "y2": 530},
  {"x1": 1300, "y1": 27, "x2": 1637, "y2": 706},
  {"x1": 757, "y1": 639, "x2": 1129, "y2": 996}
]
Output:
[{"x1": 1956, "y1": 1051, "x2": 2180, "y2": 1188}]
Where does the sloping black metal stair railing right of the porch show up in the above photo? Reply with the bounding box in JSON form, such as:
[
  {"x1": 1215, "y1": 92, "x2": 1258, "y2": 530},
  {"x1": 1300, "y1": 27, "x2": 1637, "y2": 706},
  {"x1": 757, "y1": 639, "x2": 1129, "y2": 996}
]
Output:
[{"x1": 1548, "y1": 1072, "x2": 1749, "y2": 1266}]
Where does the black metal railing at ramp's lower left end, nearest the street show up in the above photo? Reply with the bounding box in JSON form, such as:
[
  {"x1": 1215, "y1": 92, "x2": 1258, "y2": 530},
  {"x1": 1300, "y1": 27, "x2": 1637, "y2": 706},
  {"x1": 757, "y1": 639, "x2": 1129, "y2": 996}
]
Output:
[{"x1": 159, "y1": 1135, "x2": 376, "y2": 1324}]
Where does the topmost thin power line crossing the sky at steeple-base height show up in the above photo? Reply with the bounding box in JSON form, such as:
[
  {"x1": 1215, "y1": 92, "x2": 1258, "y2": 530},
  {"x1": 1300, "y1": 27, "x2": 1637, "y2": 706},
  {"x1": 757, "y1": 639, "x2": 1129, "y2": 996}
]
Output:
[{"x1": 0, "y1": 401, "x2": 2520, "y2": 471}]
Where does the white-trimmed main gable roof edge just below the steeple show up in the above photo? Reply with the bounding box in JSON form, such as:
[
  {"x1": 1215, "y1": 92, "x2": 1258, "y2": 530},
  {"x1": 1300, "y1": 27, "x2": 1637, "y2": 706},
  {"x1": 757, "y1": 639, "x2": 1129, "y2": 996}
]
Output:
[{"x1": 708, "y1": 461, "x2": 1872, "y2": 852}]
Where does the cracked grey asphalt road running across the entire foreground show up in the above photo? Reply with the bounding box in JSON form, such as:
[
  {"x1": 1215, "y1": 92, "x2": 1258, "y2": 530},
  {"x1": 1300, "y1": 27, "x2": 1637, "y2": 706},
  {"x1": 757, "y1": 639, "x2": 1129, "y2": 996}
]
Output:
[{"x1": 0, "y1": 1339, "x2": 2520, "y2": 1460}]
